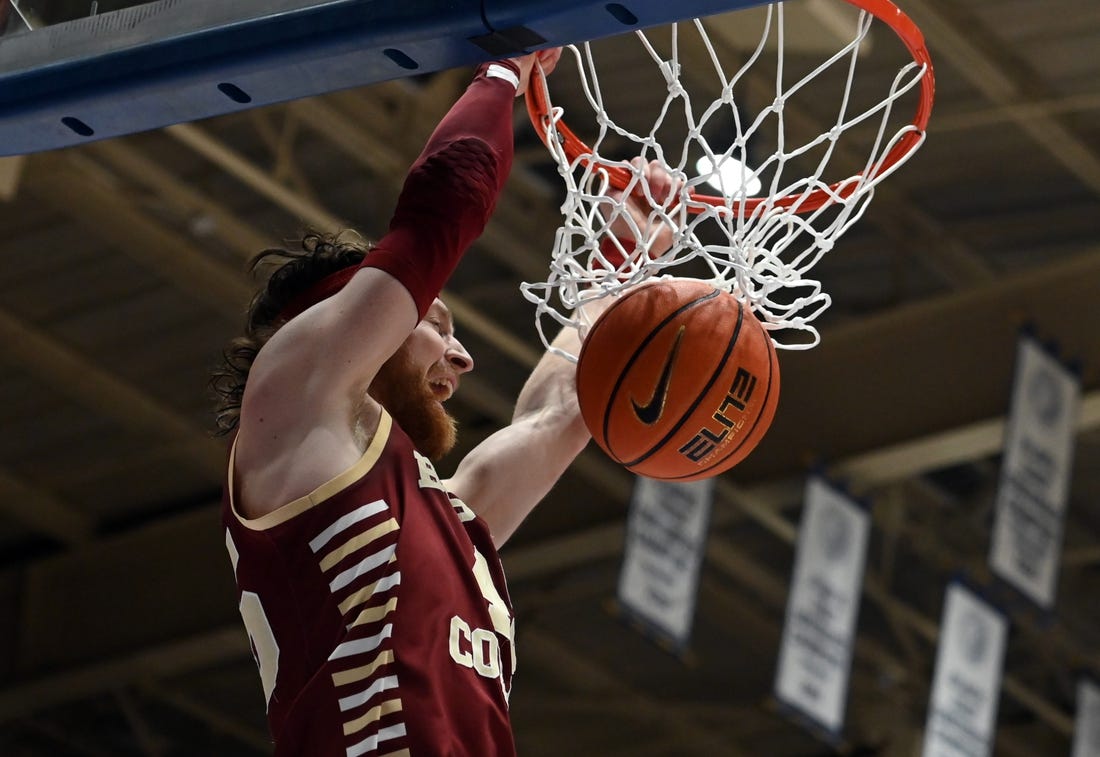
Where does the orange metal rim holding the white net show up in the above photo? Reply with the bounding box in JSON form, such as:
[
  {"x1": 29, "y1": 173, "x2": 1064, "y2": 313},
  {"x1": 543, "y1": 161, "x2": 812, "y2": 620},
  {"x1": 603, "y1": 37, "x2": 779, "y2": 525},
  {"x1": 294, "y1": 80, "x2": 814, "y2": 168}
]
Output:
[{"x1": 526, "y1": 0, "x2": 936, "y2": 213}]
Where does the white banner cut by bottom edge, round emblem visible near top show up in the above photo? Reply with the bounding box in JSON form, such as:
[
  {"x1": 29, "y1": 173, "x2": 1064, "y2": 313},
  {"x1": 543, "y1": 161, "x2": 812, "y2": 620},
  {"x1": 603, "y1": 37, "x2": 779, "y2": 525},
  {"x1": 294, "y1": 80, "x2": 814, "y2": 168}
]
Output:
[{"x1": 922, "y1": 583, "x2": 1009, "y2": 757}]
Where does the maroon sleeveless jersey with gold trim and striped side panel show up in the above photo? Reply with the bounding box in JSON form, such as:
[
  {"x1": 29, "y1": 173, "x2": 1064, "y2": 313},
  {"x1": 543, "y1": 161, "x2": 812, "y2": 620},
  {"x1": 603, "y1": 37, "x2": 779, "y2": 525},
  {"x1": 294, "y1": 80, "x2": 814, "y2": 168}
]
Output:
[{"x1": 222, "y1": 412, "x2": 516, "y2": 757}]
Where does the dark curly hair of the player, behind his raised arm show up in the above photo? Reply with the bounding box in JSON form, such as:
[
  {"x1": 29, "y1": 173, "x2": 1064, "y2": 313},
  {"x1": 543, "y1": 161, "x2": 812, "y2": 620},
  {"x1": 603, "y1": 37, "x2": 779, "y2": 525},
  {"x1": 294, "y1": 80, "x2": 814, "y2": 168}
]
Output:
[{"x1": 210, "y1": 230, "x2": 371, "y2": 435}]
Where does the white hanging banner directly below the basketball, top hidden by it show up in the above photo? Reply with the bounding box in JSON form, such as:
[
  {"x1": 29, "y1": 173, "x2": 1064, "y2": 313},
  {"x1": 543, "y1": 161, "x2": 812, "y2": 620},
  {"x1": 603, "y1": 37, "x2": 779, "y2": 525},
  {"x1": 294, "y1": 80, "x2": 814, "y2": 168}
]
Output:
[{"x1": 618, "y1": 476, "x2": 714, "y2": 647}]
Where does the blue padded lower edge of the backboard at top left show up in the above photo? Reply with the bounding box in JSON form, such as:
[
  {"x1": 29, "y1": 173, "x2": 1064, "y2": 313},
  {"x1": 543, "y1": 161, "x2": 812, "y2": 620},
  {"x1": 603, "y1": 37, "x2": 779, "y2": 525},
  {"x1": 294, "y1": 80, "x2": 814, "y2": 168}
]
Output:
[{"x1": 0, "y1": 0, "x2": 766, "y2": 155}]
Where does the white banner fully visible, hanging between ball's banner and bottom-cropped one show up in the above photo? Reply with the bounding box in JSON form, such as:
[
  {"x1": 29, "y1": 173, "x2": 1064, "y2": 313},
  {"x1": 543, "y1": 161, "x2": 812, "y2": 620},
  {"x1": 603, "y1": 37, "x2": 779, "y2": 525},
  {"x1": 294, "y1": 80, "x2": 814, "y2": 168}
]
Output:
[{"x1": 776, "y1": 478, "x2": 871, "y2": 734}]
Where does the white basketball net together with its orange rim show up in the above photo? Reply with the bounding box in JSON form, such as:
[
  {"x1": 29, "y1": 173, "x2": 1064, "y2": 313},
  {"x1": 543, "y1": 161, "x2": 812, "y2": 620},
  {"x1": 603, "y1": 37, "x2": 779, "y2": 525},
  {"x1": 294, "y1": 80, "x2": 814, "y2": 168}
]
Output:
[{"x1": 520, "y1": 0, "x2": 933, "y2": 359}]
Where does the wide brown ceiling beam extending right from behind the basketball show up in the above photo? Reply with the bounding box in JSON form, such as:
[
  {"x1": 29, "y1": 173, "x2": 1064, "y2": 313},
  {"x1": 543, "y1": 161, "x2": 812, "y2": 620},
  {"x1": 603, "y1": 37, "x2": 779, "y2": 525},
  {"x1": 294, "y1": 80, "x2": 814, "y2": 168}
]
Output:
[{"x1": 732, "y1": 244, "x2": 1100, "y2": 481}]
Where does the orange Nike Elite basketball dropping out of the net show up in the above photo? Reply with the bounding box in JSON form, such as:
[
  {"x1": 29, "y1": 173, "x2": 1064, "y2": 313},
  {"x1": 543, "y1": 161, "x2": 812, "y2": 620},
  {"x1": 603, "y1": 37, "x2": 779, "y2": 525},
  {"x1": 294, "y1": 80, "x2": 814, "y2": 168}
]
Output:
[{"x1": 576, "y1": 279, "x2": 779, "y2": 481}]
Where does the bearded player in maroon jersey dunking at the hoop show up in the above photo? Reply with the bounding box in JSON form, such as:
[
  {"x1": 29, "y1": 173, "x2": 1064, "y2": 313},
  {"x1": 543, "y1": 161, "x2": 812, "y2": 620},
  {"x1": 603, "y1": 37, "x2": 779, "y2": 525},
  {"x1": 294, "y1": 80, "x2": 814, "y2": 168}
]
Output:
[{"x1": 213, "y1": 50, "x2": 673, "y2": 757}]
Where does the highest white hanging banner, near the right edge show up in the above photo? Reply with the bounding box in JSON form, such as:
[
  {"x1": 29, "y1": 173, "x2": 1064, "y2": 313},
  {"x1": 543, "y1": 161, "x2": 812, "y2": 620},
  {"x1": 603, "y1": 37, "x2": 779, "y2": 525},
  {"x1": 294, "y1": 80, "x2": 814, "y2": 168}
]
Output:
[{"x1": 989, "y1": 337, "x2": 1081, "y2": 610}]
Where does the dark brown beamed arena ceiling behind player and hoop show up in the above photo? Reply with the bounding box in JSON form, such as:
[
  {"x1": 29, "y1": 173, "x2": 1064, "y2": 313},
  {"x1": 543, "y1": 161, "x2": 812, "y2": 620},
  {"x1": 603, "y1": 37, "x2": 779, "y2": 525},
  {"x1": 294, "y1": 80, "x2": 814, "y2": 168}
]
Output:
[{"x1": 0, "y1": 0, "x2": 1100, "y2": 757}]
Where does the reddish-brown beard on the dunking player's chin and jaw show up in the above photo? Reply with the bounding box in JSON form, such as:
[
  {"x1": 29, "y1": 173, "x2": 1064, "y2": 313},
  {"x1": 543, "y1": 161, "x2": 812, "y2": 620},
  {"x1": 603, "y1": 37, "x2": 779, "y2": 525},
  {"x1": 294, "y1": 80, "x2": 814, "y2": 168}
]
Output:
[{"x1": 367, "y1": 347, "x2": 458, "y2": 460}]
